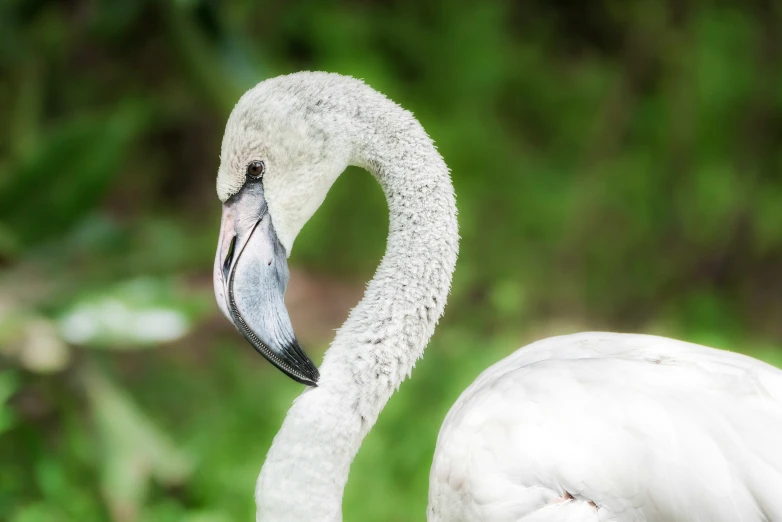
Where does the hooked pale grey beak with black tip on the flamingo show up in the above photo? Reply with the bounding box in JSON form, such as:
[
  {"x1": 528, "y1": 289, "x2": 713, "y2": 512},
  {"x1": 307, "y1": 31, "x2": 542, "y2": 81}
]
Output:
[{"x1": 214, "y1": 181, "x2": 319, "y2": 386}]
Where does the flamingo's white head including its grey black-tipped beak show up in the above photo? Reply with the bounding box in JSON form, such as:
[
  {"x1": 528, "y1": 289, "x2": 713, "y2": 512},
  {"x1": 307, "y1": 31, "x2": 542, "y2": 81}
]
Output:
[{"x1": 214, "y1": 73, "x2": 359, "y2": 385}]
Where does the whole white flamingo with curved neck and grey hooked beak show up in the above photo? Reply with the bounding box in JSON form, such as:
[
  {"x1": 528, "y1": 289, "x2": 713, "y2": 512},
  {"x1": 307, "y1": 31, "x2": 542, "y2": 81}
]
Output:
[{"x1": 214, "y1": 72, "x2": 782, "y2": 522}]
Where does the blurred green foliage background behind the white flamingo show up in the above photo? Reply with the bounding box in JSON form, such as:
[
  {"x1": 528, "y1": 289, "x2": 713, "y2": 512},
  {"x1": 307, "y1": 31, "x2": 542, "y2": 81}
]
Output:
[{"x1": 0, "y1": 0, "x2": 782, "y2": 522}]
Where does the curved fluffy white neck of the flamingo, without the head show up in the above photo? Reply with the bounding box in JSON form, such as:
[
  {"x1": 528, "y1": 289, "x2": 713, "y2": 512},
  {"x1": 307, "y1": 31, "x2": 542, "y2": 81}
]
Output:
[{"x1": 255, "y1": 95, "x2": 458, "y2": 522}]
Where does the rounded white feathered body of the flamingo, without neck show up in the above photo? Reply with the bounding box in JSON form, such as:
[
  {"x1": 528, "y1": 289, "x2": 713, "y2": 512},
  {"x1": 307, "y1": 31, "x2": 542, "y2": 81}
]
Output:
[{"x1": 428, "y1": 333, "x2": 782, "y2": 522}]
